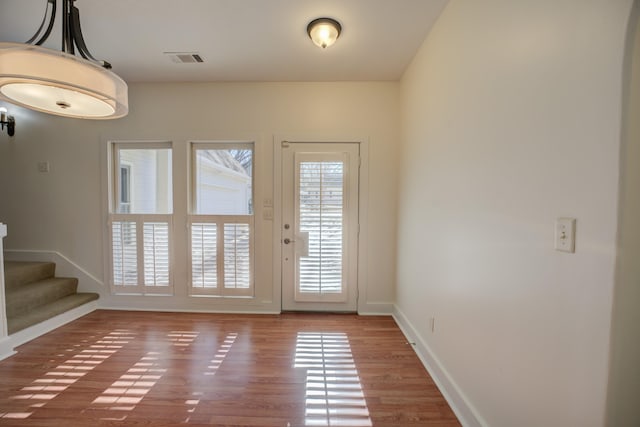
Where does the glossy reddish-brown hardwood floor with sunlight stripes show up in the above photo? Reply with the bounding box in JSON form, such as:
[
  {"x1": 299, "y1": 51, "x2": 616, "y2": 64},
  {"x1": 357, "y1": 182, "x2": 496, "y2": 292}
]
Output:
[{"x1": 0, "y1": 310, "x2": 459, "y2": 427}]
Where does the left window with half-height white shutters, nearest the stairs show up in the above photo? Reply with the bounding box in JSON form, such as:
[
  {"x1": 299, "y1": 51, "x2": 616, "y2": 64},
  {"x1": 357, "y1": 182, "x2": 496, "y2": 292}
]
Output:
[{"x1": 109, "y1": 143, "x2": 173, "y2": 295}]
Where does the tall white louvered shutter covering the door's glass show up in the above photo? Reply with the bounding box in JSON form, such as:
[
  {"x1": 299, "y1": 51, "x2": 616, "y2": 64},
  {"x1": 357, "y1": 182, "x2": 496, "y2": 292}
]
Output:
[{"x1": 296, "y1": 155, "x2": 345, "y2": 301}]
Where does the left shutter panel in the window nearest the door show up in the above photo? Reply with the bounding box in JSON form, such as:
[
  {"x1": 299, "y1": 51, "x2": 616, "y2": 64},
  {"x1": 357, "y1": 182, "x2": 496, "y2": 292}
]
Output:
[{"x1": 191, "y1": 223, "x2": 218, "y2": 289}]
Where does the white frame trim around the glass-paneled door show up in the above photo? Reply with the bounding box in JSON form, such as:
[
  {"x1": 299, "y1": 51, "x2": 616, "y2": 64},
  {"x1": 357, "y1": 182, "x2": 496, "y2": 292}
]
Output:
[{"x1": 272, "y1": 136, "x2": 369, "y2": 313}]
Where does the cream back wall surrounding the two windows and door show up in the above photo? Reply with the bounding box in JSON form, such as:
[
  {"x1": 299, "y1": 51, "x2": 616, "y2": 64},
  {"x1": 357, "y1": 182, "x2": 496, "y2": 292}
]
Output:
[{"x1": 0, "y1": 82, "x2": 400, "y2": 311}]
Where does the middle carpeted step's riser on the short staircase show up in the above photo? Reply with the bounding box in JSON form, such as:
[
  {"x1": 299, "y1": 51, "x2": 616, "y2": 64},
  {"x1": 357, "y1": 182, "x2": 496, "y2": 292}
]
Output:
[{"x1": 6, "y1": 278, "x2": 78, "y2": 318}]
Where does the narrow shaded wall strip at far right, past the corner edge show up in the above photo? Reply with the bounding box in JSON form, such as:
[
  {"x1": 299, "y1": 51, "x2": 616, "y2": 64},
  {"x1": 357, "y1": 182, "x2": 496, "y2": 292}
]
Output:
[{"x1": 607, "y1": 1, "x2": 640, "y2": 426}]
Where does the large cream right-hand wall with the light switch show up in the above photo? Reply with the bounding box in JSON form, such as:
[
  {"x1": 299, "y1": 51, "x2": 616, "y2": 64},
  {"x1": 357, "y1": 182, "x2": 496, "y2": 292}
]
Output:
[{"x1": 397, "y1": 0, "x2": 631, "y2": 427}]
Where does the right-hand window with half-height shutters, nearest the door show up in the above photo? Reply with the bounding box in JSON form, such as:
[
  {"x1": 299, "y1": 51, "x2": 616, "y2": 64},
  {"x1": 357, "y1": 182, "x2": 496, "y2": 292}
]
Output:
[{"x1": 189, "y1": 142, "x2": 254, "y2": 296}]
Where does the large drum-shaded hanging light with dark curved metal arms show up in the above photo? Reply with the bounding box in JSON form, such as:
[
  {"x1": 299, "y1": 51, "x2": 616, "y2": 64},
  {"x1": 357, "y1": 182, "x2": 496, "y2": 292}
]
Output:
[{"x1": 0, "y1": 0, "x2": 129, "y2": 119}]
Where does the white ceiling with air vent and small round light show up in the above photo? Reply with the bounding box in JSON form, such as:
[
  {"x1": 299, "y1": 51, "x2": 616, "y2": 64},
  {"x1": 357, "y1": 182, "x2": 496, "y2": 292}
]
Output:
[{"x1": 0, "y1": 0, "x2": 447, "y2": 82}]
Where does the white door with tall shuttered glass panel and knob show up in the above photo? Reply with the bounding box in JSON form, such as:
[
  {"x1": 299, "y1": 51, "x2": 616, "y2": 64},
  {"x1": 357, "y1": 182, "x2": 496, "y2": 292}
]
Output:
[{"x1": 281, "y1": 142, "x2": 359, "y2": 311}]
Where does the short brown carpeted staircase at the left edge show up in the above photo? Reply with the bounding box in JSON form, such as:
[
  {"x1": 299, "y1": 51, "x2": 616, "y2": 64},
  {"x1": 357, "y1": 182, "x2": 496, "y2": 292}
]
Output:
[{"x1": 4, "y1": 261, "x2": 98, "y2": 335}]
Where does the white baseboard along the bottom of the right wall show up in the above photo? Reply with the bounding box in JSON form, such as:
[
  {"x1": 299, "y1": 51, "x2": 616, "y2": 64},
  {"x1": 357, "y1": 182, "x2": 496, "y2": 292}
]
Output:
[{"x1": 393, "y1": 306, "x2": 488, "y2": 427}]
